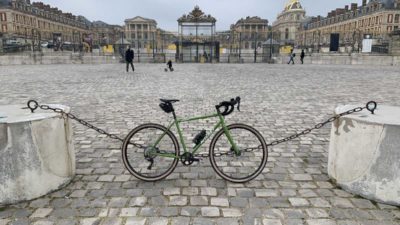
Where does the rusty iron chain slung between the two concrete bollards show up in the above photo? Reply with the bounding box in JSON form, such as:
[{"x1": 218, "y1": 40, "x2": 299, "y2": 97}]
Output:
[{"x1": 24, "y1": 100, "x2": 377, "y2": 158}]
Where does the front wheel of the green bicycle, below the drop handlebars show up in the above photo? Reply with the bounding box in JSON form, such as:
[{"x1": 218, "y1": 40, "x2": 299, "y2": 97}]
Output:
[{"x1": 210, "y1": 124, "x2": 268, "y2": 183}]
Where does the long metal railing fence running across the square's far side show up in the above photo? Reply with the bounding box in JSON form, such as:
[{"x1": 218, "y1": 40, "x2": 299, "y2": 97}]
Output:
[{"x1": 0, "y1": 29, "x2": 393, "y2": 60}]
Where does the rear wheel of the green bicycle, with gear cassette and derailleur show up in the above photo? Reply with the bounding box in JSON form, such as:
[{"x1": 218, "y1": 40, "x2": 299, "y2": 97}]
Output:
[{"x1": 122, "y1": 124, "x2": 179, "y2": 181}]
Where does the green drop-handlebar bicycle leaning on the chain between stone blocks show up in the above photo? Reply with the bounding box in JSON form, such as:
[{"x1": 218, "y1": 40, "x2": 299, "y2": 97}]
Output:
[{"x1": 122, "y1": 97, "x2": 268, "y2": 183}]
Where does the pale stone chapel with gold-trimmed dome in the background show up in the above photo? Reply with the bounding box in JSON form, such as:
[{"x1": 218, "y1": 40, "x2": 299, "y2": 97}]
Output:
[{"x1": 272, "y1": 0, "x2": 306, "y2": 45}]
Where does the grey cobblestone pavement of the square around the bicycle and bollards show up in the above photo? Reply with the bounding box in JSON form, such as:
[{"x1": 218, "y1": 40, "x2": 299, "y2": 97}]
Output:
[{"x1": 0, "y1": 64, "x2": 400, "y2": 225}]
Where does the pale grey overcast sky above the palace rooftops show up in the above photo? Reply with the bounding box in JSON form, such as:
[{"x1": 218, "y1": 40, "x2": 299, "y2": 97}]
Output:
[{"x1": 34, "y1": 0, "x2": 362, "y2": 31}]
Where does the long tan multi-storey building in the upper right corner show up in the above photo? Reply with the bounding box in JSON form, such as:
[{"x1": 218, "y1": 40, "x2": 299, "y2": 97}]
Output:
[{"x1": 298, "y1": 0, "x2": 400, "y2": 49}]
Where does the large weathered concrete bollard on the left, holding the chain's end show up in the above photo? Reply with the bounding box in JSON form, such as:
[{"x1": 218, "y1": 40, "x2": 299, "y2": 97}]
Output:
[{"x1": 0, "y1": 105, "x2": 75, "y2": 205}]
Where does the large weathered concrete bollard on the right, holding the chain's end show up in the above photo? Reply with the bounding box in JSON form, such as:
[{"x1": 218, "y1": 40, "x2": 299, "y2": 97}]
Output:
[{"x1": 328, "y1": 105, "x2": 400, "y2": 206}]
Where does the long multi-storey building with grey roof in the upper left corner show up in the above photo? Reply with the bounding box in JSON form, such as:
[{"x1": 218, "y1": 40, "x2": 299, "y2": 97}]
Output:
[{"x1": 0, "y1": 0, "x2": 89, "y2": 43}]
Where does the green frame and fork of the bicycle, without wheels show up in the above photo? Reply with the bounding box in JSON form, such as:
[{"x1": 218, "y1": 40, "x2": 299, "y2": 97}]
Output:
[{"x1": 153, "y1": 112, "x2": 240, "y2": 159}]
